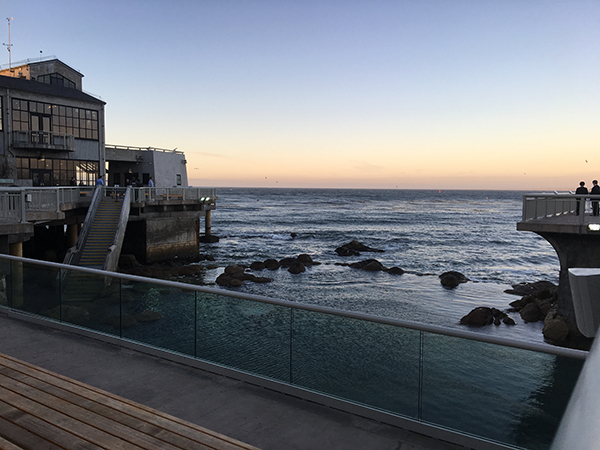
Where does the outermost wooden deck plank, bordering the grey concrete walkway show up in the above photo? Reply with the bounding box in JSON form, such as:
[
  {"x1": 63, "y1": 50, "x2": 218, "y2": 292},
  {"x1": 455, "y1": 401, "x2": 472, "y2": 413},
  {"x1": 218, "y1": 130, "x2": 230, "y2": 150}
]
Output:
[{"x1": 0, "y1": 354, "x2": 259, "y2": 450}]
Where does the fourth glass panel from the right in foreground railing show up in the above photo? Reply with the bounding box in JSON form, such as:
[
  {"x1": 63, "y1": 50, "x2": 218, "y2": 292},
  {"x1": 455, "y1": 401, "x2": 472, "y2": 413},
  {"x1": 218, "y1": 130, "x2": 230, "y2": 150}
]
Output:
[{"x1": 121, "y1": 280, "x2": 195, "y2": 356}]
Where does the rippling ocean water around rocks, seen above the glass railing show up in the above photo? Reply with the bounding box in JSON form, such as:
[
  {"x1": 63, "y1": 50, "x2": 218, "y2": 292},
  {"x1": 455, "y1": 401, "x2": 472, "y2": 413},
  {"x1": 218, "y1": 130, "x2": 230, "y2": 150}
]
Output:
[{"x1": 200, "y1": 188, "x2": 559, "y2": 342}]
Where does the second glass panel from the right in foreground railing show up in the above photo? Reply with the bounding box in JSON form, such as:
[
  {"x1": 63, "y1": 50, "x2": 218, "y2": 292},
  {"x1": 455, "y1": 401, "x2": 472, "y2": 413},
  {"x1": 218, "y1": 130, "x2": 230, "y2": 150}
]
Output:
[{"x1": 292, "y1": 310, "x2": 420, "y2": 418}]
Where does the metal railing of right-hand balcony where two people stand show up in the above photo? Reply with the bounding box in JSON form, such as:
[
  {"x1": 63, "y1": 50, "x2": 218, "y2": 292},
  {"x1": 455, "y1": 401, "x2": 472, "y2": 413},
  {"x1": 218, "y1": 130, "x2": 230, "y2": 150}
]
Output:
[{"x1": 522, "y1": 193, "x2": 600, "y2": 224}]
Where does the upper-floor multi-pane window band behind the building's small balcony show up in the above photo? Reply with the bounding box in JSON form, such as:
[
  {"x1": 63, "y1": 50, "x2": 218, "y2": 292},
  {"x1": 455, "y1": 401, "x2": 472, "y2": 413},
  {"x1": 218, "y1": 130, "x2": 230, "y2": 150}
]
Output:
[{"x1": 12, "y1": 99, "x2": 98, "y2": 141}]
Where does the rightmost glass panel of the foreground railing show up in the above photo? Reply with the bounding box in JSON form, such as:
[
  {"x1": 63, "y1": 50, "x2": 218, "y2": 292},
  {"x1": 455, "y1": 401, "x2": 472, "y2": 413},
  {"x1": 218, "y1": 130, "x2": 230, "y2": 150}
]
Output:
[{"x1": 422, "y1": 333, "x2": 582, "y2": 450}]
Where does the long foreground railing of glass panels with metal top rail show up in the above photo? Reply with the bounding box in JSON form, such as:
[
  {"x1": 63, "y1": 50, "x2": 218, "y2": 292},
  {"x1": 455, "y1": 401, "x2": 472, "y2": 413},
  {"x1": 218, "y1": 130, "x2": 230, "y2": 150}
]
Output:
[{"x1": 0, "y1": 255, "x2": 588, "y2": 450}]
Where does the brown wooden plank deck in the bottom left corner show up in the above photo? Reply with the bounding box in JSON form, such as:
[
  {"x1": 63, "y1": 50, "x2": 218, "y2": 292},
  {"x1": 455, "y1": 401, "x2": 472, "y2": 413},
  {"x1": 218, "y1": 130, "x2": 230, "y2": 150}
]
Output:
[{"x1": 0, "y1": 354, "x2": 257, "y2": 450}]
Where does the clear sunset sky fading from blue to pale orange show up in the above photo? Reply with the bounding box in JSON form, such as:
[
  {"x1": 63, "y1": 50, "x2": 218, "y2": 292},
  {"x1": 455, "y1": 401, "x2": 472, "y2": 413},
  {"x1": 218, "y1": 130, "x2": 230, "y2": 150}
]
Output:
[{"x1": 0, "y1": 0, "x2": 600, "y2": 190}]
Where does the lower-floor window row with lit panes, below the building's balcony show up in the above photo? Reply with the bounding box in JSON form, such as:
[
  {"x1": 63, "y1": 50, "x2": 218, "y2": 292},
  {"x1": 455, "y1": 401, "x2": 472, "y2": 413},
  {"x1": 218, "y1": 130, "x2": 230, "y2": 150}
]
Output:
[{"x1": 17, "y1": 158, "x2": 99, "y2": 186}]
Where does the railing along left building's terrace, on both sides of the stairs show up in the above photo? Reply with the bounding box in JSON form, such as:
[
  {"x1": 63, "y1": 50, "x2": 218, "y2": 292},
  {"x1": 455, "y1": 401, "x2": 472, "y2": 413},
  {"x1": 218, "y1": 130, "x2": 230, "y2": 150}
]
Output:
[{"x1": 0, "y1": 186, "x2": 217, "y2": 223}]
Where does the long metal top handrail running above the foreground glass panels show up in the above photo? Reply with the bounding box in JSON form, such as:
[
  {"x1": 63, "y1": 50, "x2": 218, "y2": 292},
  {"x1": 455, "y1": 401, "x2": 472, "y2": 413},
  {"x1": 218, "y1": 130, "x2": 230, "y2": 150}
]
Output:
[{"x1": 0, "y1": 255, "x2": 589, "y2": 359}]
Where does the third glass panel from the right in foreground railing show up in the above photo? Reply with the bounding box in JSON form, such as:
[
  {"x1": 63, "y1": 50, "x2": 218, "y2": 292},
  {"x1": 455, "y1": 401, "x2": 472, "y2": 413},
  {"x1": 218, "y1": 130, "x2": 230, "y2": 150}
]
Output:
[{"x1": 196, "y1": 292, "x2": 291, "y2": 382}]
